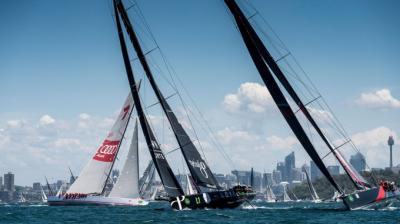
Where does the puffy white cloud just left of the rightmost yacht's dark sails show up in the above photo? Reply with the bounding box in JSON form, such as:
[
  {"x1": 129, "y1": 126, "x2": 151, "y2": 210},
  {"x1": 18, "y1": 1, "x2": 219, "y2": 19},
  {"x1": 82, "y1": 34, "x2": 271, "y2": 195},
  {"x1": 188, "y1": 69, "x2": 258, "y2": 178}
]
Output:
[{"x1": 222, "y1": 82, "x2": 273, "y2": 114}]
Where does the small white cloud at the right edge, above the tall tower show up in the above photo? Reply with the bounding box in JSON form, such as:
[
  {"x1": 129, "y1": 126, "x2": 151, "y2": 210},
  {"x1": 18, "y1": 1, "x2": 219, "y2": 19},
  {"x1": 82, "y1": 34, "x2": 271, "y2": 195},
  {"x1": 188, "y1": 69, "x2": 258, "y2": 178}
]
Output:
[{"x1": 356, "y1": 88, "x2": 400, "y2": 109}]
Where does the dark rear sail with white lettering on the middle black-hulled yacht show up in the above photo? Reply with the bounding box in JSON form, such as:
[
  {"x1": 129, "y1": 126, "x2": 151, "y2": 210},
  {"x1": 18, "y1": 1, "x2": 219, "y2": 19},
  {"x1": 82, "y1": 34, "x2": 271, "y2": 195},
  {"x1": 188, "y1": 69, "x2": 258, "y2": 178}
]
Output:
[{"x1": 117, "y1": 1, "x2": 219, "y2": 188}]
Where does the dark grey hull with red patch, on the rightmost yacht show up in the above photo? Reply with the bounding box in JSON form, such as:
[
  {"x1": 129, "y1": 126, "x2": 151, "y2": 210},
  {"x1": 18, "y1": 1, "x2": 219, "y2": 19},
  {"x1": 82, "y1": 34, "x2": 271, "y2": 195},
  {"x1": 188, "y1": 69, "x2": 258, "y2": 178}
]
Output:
[{"x1": 342, "y1": 187, "x2": 400, "y2": 210}]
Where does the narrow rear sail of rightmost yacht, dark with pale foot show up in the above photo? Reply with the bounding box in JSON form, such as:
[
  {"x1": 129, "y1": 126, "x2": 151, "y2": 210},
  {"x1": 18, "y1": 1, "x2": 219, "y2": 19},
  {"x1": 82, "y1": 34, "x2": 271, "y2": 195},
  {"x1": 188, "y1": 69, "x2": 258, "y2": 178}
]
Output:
[{"x1": 228, "y1": 3, "x2": 369, "y2": 189}]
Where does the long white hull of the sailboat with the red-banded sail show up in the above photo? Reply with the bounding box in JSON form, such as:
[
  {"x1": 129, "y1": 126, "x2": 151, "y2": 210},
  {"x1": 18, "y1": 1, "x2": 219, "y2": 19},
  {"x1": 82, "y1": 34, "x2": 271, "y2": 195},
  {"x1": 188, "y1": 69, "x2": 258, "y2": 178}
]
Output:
[{"x1": 47, "y1": 195, "x2": 149, "y2": 206}]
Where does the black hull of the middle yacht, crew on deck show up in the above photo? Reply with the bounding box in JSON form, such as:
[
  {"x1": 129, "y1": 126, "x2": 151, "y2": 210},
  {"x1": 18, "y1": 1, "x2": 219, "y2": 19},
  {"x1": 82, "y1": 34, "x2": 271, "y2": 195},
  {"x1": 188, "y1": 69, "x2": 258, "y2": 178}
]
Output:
[{"x1": 170, "y1": 189, "x2": 256, "y2": 210}]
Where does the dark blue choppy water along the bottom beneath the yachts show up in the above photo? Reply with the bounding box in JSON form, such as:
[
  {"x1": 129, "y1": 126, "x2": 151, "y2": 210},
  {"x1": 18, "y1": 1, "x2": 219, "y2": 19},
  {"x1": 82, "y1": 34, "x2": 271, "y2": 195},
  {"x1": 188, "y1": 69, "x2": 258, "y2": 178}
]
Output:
[{"x1": 0, "y1": 202, "x2": 400, "y2": 224}]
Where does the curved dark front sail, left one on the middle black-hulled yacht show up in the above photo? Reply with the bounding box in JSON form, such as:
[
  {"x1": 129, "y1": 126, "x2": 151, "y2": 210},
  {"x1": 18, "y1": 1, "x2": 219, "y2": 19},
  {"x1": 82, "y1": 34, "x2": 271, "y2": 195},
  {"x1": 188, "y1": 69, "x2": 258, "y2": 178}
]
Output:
[{"x1": 114, "y1": 0, "x2": 184, "y2": 197}]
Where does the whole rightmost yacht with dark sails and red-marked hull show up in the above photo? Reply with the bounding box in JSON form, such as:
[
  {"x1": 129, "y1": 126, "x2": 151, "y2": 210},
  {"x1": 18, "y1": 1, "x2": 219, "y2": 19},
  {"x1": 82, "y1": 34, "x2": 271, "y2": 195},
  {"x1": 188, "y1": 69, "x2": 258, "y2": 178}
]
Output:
[{"x1": 224, "y1": 0, "x2": 400, "y2": 210}]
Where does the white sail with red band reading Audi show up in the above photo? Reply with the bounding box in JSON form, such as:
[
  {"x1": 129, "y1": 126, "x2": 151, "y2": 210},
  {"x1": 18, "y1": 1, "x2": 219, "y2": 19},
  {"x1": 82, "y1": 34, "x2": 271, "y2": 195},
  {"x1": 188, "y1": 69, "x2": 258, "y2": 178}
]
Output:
[{"x1": 67, "y1": 94, "x2": 133, "y2": 194}]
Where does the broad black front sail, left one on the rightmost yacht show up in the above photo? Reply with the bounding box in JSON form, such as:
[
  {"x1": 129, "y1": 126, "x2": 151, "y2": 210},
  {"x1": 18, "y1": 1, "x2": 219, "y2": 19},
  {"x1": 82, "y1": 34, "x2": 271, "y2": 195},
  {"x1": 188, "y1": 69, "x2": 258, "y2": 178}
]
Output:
[{"x1": 225, "y1": 0, "x2": 343, "y2": 192}]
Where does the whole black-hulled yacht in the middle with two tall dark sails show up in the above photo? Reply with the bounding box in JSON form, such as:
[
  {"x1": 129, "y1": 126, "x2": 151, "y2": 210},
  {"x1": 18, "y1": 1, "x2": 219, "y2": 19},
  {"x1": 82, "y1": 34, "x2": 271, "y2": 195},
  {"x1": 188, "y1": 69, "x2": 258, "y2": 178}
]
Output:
[{"x1": 113, "y1": 0, "x2": 255, "y2": 210}]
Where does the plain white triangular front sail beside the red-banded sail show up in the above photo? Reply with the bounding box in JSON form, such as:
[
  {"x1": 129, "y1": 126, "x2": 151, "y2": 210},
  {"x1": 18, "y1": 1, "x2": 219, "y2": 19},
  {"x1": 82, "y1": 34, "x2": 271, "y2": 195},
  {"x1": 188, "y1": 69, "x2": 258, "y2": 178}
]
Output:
[{"x1": 109, "y1": 121, "x2": 139, "y2": 198}]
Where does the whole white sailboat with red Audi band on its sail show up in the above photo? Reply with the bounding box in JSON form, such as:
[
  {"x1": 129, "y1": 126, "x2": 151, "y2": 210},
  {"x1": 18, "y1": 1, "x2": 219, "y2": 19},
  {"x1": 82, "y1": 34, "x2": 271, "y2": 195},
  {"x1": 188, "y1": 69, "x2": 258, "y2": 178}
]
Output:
[{"x1": 47, "y1": 94, "x2": 148, "y2": 206}]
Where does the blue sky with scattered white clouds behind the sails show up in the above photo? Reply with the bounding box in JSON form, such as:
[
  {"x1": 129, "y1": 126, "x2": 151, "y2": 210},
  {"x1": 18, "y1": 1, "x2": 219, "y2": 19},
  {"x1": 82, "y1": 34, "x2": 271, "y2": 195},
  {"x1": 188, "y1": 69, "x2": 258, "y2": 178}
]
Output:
[{"x1": 0, "y1": 0, "x2": 400, "y2": 185}]
